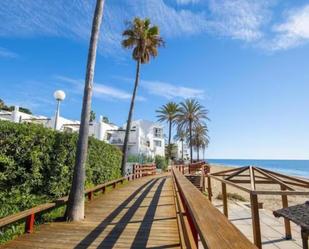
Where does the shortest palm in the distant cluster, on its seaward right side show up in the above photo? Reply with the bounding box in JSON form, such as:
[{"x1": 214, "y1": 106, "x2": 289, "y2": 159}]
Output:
[{"x1": 191, "y1": 125, "x2": 209, "y2": 161}]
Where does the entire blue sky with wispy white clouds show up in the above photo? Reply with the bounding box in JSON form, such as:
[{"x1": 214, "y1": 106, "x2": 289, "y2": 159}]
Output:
[{"x1": 0, "y1": 0, "x2": 309, "y2": 159}]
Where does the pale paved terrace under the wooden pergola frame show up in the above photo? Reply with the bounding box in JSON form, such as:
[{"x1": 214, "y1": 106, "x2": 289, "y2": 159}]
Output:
[{"x1": 214, "y1": 200, "x2": 302, "y2": 249}]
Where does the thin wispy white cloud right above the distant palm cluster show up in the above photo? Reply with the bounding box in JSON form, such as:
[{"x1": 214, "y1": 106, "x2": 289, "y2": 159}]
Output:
[{"x1": 141, "y1": 80, "x2": 205, "y2": 99}]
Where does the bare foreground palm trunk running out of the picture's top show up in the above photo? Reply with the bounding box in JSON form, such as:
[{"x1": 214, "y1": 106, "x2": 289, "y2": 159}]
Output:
[{"x1": 65, "y1": 0, "x2": 104, "y2": 221}]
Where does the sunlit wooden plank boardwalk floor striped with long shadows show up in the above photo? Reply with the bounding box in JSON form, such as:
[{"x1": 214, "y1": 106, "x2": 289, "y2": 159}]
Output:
[{"x1": 0, "y1": 176, "x2": 180, "y2": 249}]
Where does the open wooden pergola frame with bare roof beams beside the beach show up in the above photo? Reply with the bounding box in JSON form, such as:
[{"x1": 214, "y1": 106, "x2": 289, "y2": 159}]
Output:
[{"x1": 207, "y1": 166, "x2": 309, "y2": 248}]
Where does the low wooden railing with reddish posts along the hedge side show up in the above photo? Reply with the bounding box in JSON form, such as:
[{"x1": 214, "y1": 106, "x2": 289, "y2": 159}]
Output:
[{"x1": 0, "y1": 165, "x2": 156, "y2": 233}]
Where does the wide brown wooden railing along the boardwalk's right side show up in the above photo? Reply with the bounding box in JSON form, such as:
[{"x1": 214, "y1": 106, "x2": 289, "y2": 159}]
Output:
[{"x1": 172, "y1": 167, "x2": 256, "y2": 249}]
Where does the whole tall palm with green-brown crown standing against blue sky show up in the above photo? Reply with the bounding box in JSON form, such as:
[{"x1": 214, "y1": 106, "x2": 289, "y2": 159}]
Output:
[{"x1": 121, "y1": 17, "x2": 163, "y2": 175}]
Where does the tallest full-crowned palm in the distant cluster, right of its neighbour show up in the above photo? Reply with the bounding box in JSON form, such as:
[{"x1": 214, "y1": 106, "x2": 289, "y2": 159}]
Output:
[{"x1": 177, "y1": 99, "x2": 209, "y2": 163}]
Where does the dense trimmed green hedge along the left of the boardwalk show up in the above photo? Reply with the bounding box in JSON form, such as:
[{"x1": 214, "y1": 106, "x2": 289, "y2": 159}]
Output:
[{"x1": 0, "y1": 121, "x2": 121, "y2": 217}]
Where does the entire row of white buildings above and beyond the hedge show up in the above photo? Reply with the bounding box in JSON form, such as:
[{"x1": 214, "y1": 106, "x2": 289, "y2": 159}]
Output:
[{"x1": 0, "y1": 106, "x2": 165, "y2": 157}]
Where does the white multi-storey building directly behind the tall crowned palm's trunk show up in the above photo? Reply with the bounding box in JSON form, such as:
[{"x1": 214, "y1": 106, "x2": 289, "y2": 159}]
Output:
[{"x1": 110, "y1": 120, "x2": 165, "y2": 157}]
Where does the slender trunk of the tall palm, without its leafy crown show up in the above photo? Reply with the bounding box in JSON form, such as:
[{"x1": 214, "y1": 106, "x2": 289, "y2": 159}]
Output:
[{"x1": 121, "y1": 59, "x2": 141, "y2": 176}]
